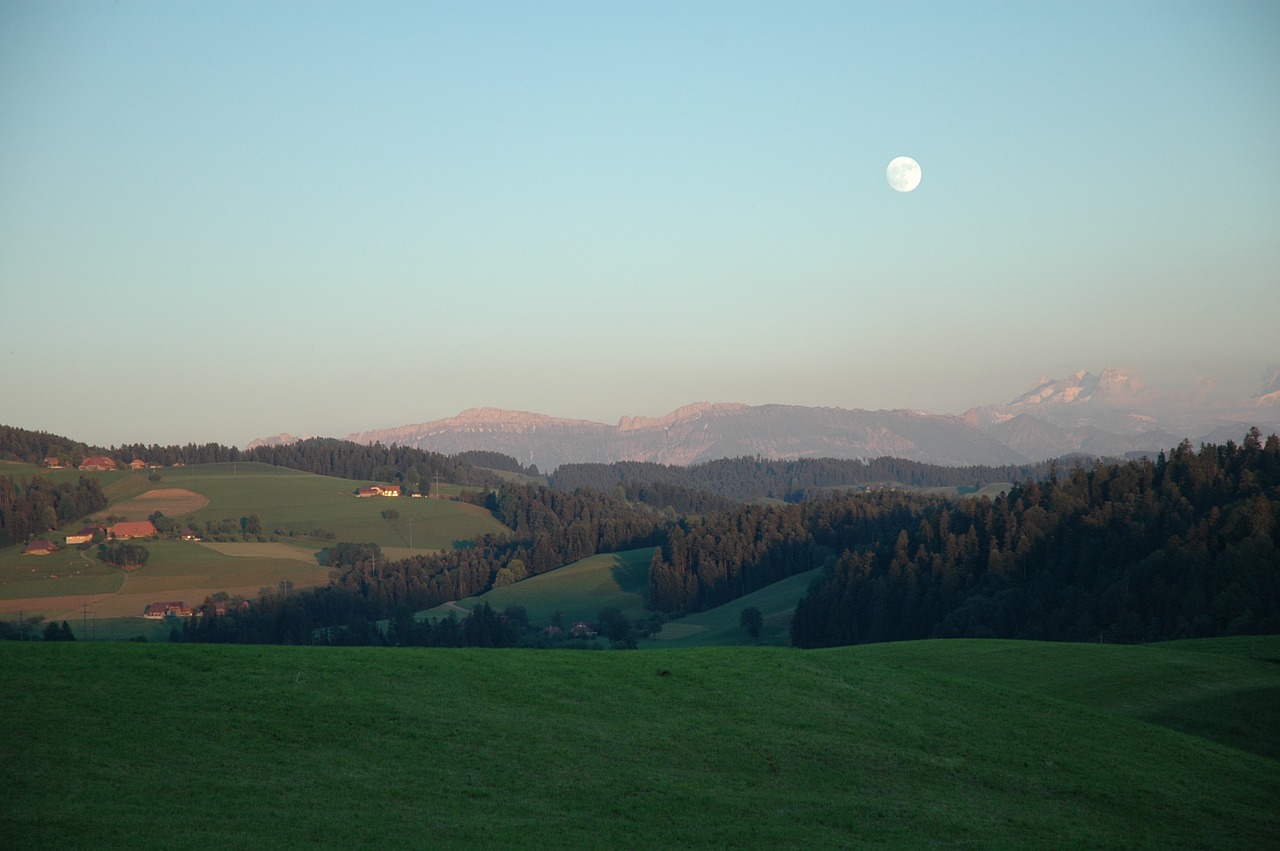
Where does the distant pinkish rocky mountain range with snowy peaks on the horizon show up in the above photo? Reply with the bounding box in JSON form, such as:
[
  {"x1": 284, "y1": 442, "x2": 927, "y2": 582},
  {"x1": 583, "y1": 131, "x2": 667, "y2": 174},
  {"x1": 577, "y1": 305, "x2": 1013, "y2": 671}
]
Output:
[{"x1": 250, "y1": 367, "x2": 1280, "y2": 472}]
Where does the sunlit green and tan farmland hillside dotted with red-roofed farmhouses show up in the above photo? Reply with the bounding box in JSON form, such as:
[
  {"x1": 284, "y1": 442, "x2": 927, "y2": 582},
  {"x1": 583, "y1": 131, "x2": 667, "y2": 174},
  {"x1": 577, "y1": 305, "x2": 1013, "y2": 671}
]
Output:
[{"x1": 0, "y1": 463, "x2": 507, "y2": 624}]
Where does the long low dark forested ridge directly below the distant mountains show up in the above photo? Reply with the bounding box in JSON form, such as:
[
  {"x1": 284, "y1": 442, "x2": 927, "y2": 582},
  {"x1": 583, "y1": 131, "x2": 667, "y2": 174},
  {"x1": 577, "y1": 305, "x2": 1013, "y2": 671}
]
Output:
[{"x1": 550, "y1": 458, "x2": 1068, "y2": 502}]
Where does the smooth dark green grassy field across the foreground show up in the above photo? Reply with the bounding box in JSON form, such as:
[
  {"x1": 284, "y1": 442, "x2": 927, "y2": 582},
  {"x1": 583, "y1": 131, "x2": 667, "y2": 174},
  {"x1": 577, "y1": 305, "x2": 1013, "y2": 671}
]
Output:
[{"x1": 0, "y1": 641, "x2": 1280, "y2": 848}]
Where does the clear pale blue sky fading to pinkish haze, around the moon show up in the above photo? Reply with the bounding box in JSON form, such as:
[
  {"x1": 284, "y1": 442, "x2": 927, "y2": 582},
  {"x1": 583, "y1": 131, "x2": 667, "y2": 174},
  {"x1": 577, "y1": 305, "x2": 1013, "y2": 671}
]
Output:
[{"x1": 0, "y1": 0, "x2": 1280, "y2": 447}]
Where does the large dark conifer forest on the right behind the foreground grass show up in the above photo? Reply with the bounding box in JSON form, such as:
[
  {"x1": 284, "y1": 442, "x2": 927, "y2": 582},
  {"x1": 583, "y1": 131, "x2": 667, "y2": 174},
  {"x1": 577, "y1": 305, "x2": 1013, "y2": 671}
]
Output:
[{"x1": 791, "y1": 429, "x2": 1280, "y2": 648}]
